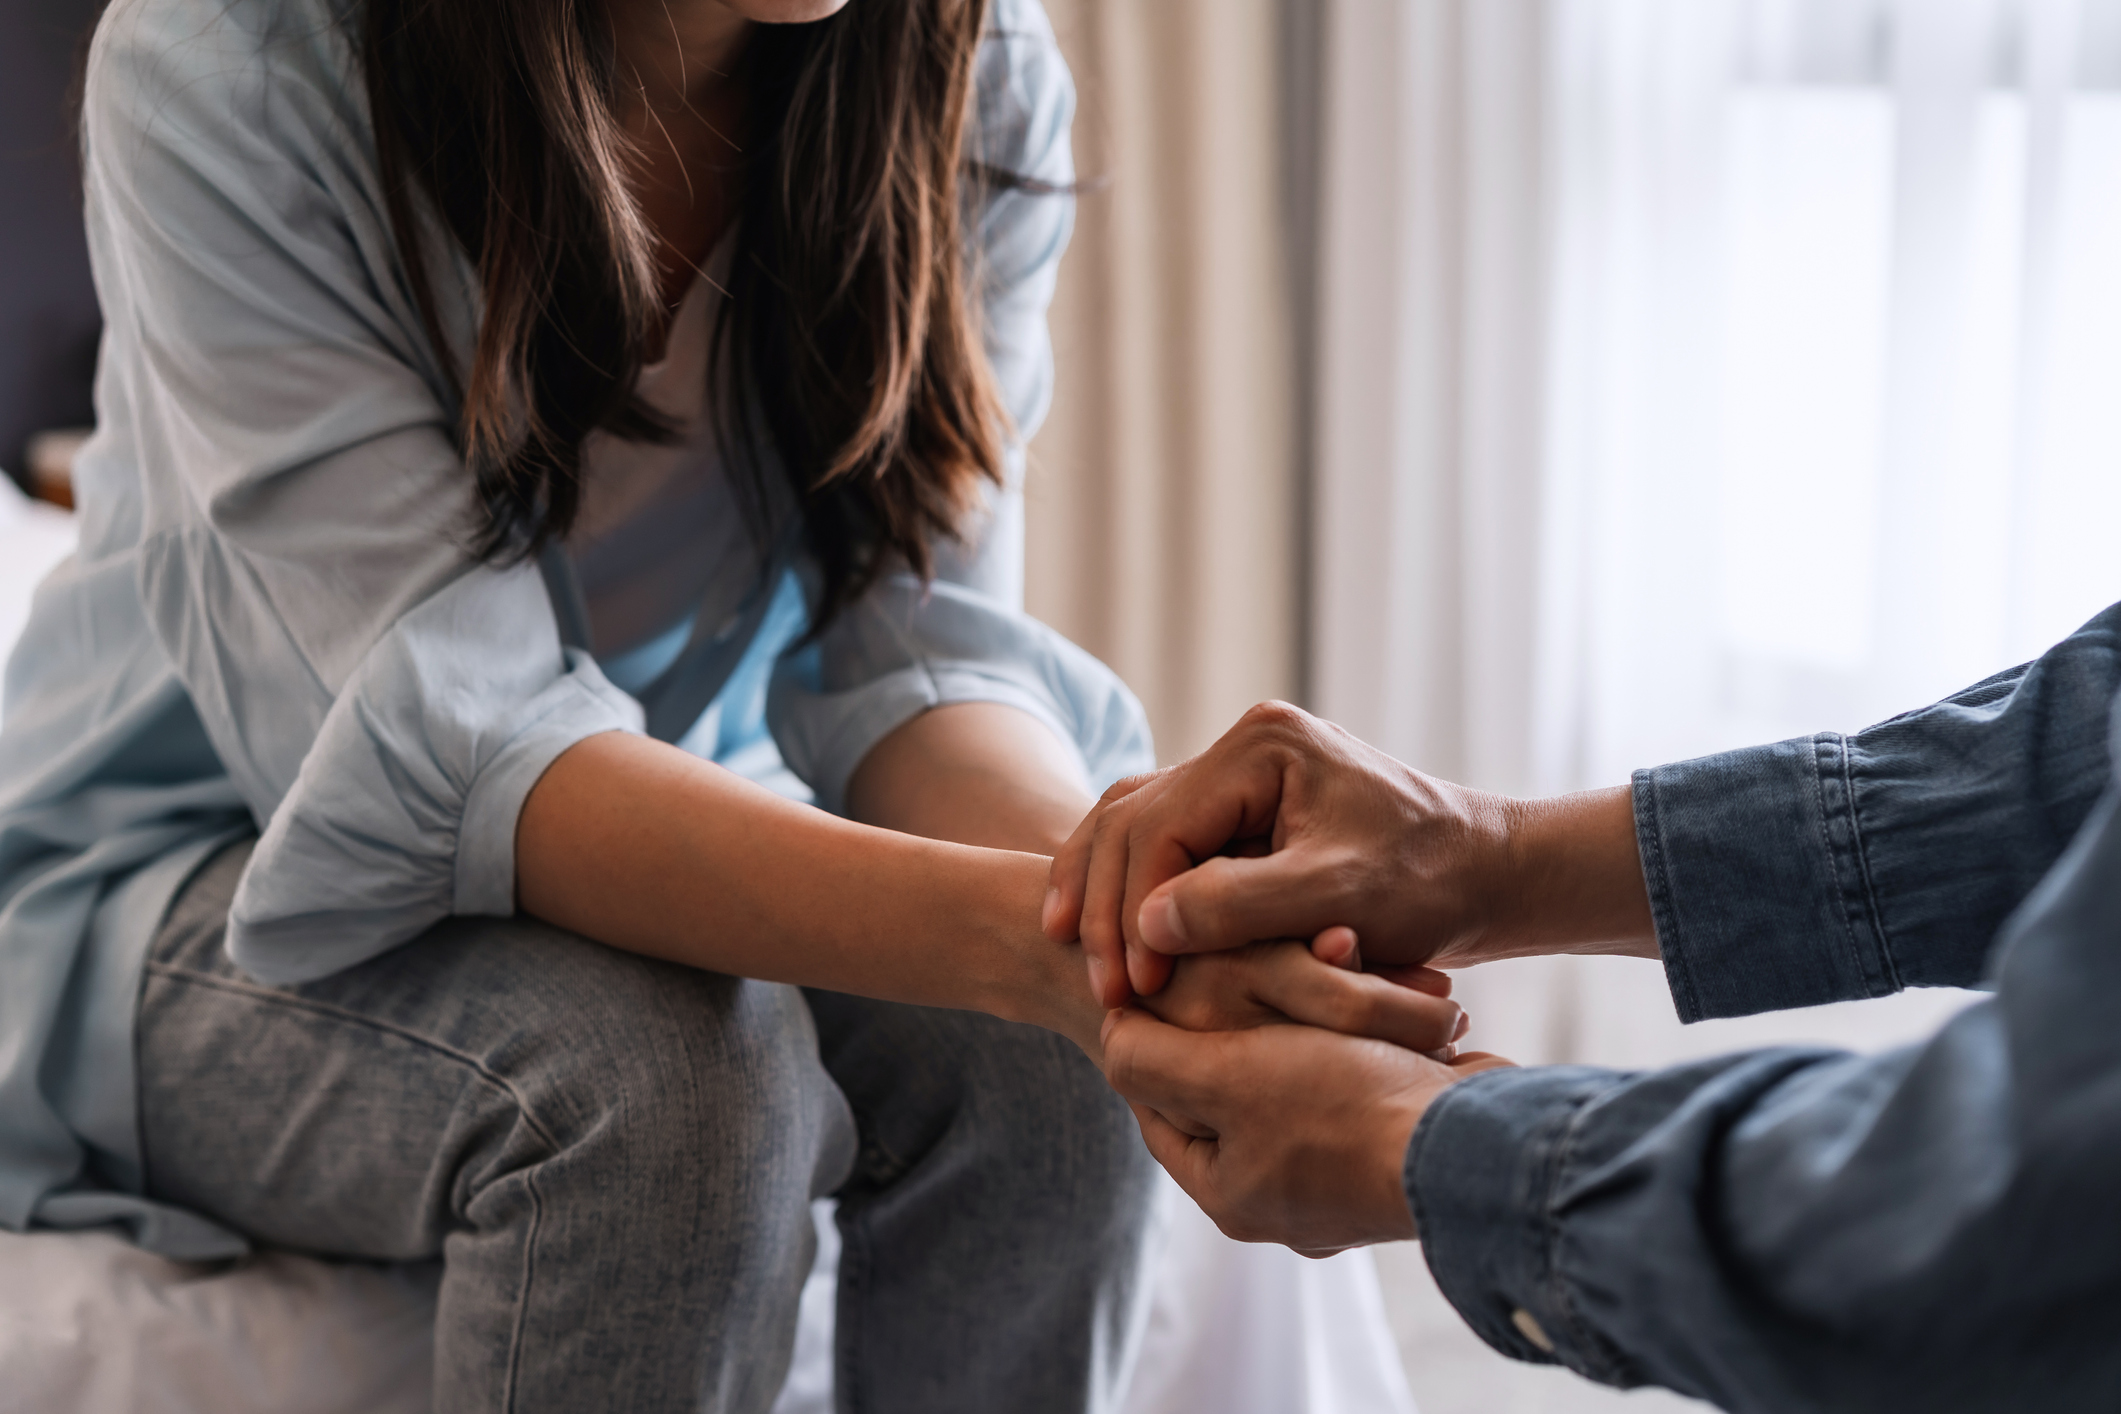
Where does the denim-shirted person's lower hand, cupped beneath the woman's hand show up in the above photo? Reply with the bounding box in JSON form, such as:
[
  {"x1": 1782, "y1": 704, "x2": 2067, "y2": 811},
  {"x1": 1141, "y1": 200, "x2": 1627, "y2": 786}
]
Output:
[{"x1": 1103, "y1": 1004, "x2": 1510, "y2": 1257}]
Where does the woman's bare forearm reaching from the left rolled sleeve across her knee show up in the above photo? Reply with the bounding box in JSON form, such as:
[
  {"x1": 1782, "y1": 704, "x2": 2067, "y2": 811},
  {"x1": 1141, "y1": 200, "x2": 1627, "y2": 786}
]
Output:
[{"x1": 515, "y1": 733, "x2": 1103, "y2": 1054}]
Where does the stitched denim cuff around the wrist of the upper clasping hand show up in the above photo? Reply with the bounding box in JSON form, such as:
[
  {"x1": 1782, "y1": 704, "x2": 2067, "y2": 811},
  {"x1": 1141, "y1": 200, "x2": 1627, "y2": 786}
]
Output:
[{"x1": 1635, "y1": 731, "x2": 1903, "y2": 1022}]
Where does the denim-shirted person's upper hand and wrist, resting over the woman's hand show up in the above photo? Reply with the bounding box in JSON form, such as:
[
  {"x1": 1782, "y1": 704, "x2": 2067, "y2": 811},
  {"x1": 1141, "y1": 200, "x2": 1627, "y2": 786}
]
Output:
[{"x1": 1041, "y1": 702, "x2": 1657, "y2": 1007}]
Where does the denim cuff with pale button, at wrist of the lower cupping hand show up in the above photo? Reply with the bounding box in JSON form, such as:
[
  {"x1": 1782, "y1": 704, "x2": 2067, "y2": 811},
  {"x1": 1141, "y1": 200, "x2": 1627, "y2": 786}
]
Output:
[{"x1": 1404, "y1": 1066, "x2": 1633, "y2": 1384}]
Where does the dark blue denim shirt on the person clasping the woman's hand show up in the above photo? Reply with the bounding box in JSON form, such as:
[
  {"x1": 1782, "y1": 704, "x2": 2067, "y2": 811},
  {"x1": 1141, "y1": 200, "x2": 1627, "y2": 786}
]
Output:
[{"x1": 1406, "y1": 604, "x2": 2121, "y2": 1414}]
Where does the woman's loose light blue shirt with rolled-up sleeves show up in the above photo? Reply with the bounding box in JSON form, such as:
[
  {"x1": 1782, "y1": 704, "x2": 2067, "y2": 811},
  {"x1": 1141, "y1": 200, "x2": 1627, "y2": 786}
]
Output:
[{"x1": 0, "y1": 0, "x2": 1150, "y2": 1257}]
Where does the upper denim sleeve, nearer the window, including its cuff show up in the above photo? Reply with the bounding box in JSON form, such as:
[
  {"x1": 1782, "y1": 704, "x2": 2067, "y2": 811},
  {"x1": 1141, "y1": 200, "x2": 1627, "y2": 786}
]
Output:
[{"x1": 1635, "y1": 604, "x2": 2121, "y2": 1022}]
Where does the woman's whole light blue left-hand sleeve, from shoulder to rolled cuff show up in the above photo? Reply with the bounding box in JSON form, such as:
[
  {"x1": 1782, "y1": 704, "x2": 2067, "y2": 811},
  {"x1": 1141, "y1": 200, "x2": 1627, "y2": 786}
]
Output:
[{"x1": 85, "y1": 0, "x2": 641, "y2": 982}]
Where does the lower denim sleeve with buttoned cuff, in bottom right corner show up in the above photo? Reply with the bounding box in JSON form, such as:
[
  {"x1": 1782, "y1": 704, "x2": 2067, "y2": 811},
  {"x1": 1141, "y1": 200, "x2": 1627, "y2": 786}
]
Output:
[{"x1": 1406, "y1": 729, "x2": 2121, "y2": 1414}]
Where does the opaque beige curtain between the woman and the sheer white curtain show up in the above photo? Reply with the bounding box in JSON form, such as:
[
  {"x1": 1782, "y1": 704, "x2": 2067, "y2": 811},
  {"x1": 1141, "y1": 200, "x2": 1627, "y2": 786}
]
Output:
[{"x1": 1027, "y1": 0, "x2": 1302, "y2": 761}]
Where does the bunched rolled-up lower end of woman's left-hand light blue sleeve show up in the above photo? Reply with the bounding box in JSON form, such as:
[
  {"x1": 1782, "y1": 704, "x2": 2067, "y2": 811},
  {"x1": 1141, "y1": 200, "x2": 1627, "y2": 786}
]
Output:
[{"x1": 199, "y1": 555, "x2": 641, "y2": 984}]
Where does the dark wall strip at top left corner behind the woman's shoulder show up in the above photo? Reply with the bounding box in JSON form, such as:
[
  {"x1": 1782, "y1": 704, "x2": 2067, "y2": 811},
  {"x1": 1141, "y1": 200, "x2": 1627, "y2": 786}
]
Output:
[{"x1": 0, "y1": 0, "x2": 102, "y2": 489}]
